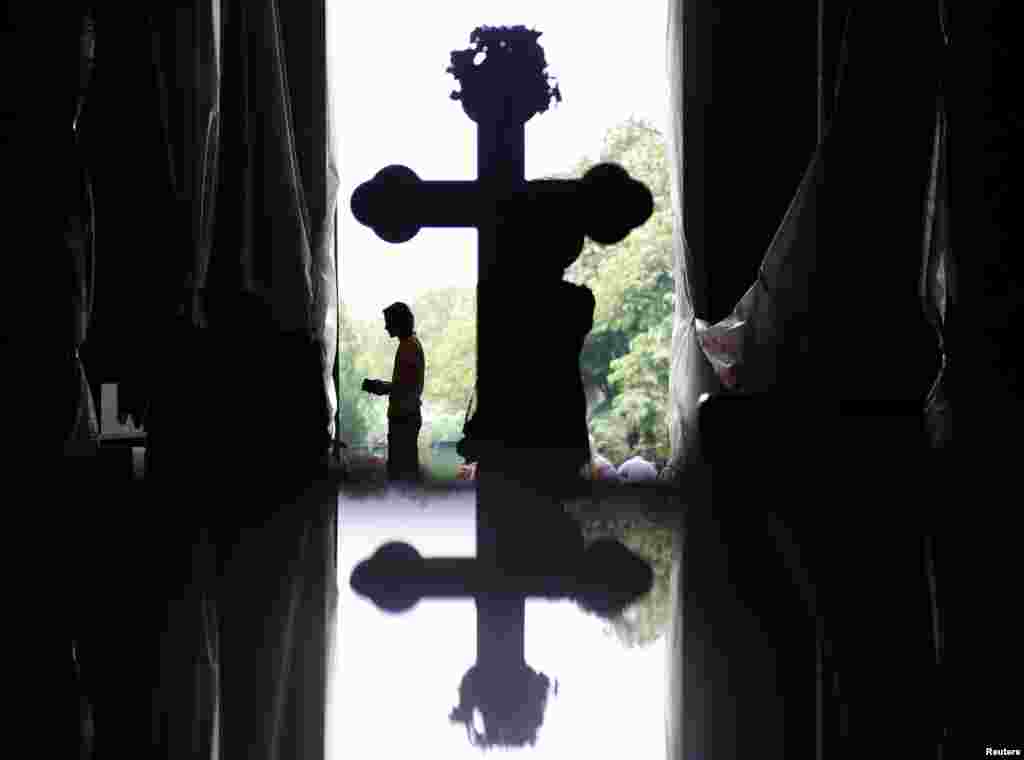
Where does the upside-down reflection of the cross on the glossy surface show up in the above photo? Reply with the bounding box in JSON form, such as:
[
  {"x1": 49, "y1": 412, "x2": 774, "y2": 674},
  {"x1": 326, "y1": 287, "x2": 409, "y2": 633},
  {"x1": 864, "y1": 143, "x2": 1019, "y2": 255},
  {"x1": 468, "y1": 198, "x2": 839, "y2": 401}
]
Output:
[{"x1": 351, "y1": 503, "x2": 654, "y2": 746}]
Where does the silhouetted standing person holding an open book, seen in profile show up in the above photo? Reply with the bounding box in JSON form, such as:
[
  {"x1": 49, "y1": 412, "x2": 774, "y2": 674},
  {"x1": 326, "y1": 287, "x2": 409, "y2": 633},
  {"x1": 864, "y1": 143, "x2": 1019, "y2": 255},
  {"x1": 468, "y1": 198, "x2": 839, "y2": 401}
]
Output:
[{"x1": 362, "y1": 301, "x2": 426, "y2": 480}]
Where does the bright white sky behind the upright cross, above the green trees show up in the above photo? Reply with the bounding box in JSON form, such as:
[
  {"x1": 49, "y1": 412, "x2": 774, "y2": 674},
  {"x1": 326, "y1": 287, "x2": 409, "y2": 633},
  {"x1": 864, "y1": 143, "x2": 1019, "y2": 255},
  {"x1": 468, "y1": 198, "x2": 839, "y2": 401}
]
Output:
[{"x1": 328, "y1": 0, "x2": 668, "y2": 319}]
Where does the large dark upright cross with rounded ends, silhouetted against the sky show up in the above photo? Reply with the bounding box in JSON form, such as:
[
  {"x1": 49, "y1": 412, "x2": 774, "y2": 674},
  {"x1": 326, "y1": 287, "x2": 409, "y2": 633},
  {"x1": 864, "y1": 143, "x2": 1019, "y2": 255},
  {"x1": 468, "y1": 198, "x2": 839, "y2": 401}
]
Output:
[{"x1": 351, "y1": 27, "x2": 653, "y2": 440}]
